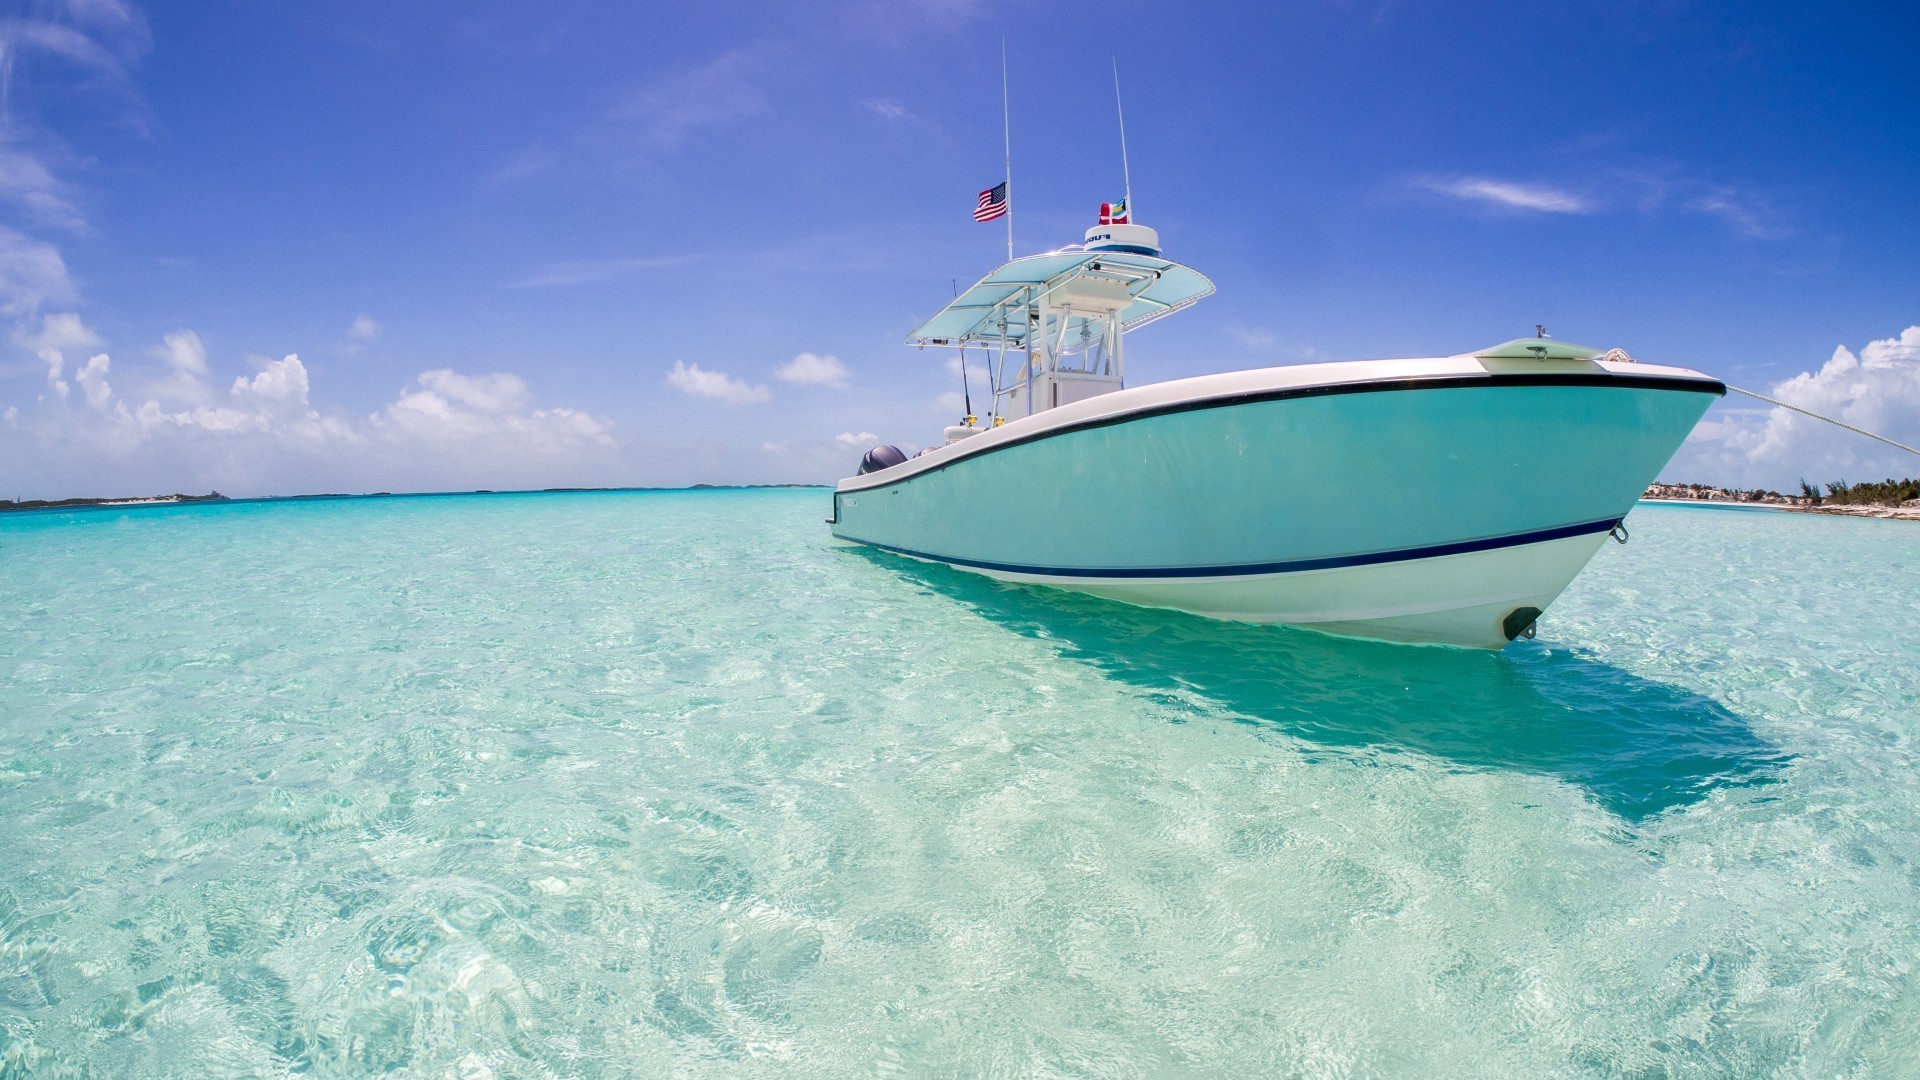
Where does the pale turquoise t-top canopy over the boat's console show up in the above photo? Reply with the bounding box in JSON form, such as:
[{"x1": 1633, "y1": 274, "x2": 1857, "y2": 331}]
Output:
[{"x1": 906, "y1": 252, "x2": 1213, "y2": 348}]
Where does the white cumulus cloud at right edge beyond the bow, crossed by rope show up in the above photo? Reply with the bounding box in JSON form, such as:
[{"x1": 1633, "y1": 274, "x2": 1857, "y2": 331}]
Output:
[{"x1": 1663, "y1": 327, "x2": 1920, "y2": 490}]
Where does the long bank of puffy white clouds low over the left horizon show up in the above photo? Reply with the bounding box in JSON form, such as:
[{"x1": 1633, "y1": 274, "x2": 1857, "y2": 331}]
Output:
[{"x1": 0, "y1": 332, "x2": 616, "y2": 496}]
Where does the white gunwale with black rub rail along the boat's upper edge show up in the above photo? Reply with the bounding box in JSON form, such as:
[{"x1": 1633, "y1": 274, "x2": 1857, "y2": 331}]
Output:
[{"x1": 833, "y1": 361, "x2": 1726, "y2": 495}]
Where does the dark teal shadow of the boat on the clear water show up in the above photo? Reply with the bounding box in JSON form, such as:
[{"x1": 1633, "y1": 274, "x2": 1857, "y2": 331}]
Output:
[{"x1": 849, "y1": 548, "x2": 1789, "y2": 822}]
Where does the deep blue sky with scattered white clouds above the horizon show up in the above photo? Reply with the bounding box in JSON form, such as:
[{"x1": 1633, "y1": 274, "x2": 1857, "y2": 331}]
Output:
[{"x1": 0, "y1": 0, "x2": 1920, "y2": 498}]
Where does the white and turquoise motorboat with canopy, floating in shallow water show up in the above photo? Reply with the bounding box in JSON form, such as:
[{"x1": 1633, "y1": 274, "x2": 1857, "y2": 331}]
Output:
[{"x1": 831, "y1": 214, "x2": 1726, "y2": 648}]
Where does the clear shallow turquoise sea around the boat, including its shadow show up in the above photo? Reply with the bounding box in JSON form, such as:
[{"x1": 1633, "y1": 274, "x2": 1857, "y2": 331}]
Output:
[{"x1": 0, "y1": 492, "x2": 1920, "y2": 1076}]
